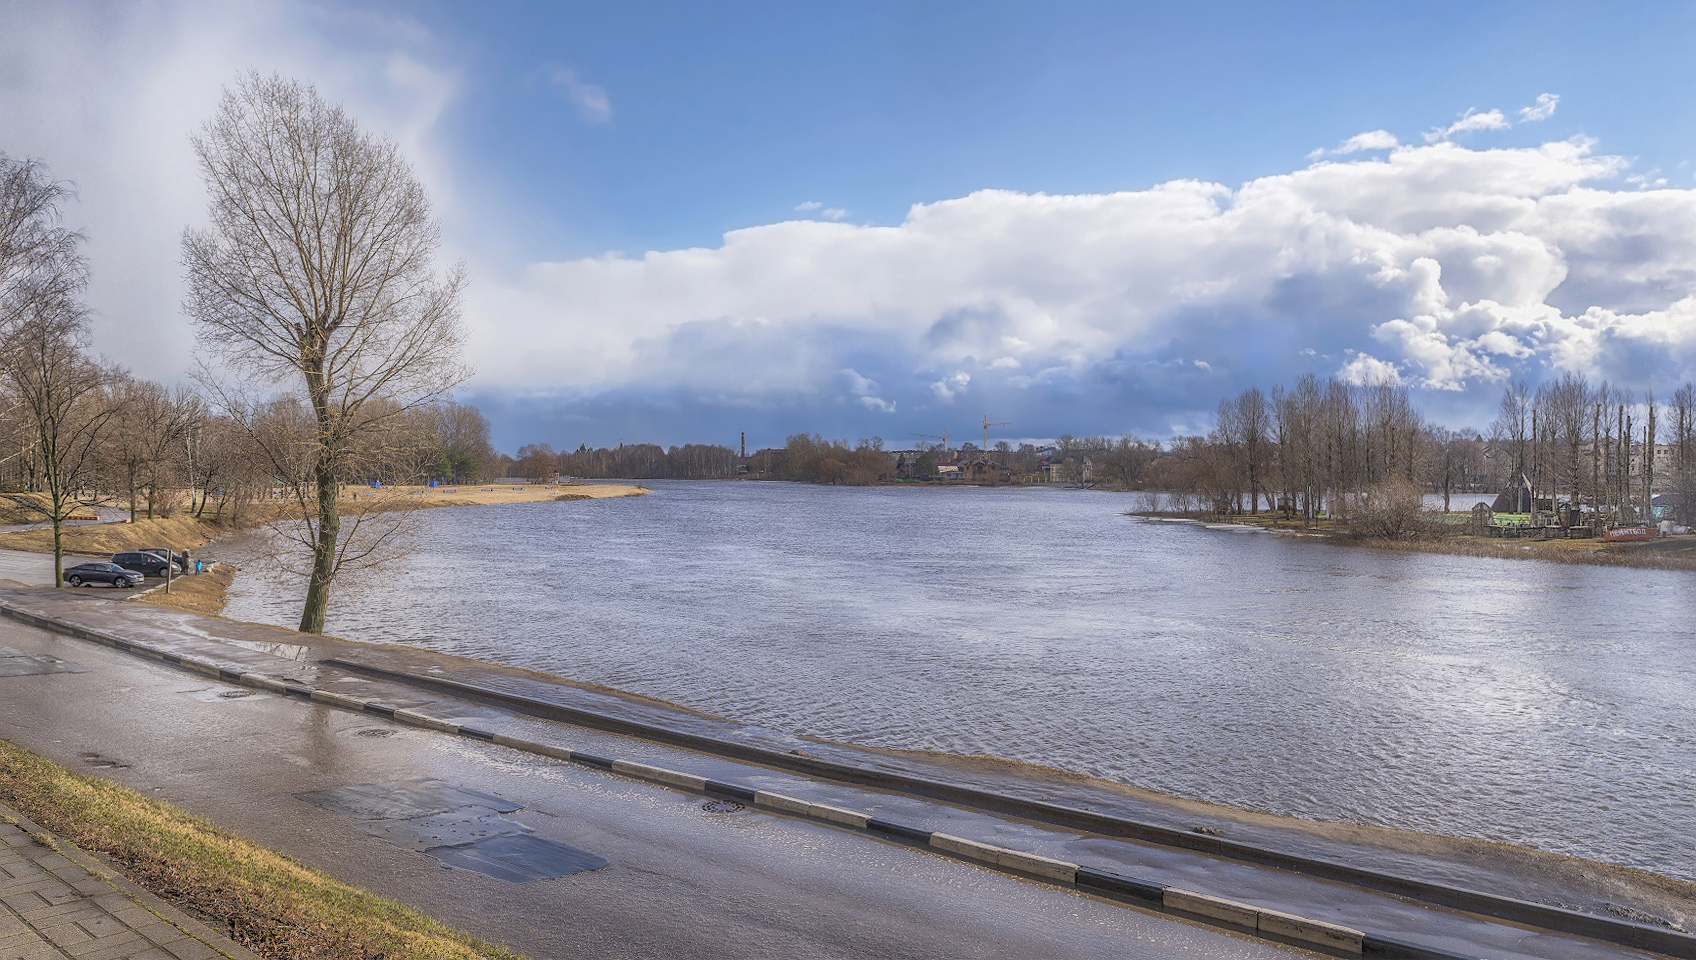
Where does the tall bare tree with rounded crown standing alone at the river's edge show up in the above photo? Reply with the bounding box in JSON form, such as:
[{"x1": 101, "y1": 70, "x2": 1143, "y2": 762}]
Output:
[{"x1": 183, "y1": 73, "x2": 465, "y2": 633}]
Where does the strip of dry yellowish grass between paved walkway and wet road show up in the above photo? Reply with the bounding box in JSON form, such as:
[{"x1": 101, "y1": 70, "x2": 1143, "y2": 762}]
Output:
[{"x1": 0, "y1": 741, "x2": 522, "y2": 960}]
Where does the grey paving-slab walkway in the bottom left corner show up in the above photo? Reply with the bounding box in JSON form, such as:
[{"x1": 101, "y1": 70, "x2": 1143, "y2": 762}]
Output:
[{"x1": 0, "y1": 804, "x2": 256, "y2": 960}]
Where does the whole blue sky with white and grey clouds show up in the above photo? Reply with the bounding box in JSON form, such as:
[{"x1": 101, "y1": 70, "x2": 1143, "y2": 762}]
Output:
[{"x1": 0, "y1": 0, "x2": 1696, "y2": 451}]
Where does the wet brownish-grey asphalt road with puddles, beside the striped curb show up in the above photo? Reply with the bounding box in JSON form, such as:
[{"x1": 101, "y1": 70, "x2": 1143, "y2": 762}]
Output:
[{"x1": 0, "y1": 622, "x2": 1311, "y2": 960}]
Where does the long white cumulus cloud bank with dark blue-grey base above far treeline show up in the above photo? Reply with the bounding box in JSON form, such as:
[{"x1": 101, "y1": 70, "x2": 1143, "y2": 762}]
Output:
[{"x1": 475, "y1": 139, "x2": 1696, "y2": 444}]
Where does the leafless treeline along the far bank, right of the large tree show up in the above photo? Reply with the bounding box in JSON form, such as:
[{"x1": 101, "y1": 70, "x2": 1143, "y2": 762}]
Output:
[{"x1": 498, "y1": 375, "x2": 1696, "y2": 519}]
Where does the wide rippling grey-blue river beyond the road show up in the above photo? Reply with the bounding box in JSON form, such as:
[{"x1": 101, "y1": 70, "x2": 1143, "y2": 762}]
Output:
[{"x1": 226, "y1": 483, "x2": 1696, "y2": 879}]
